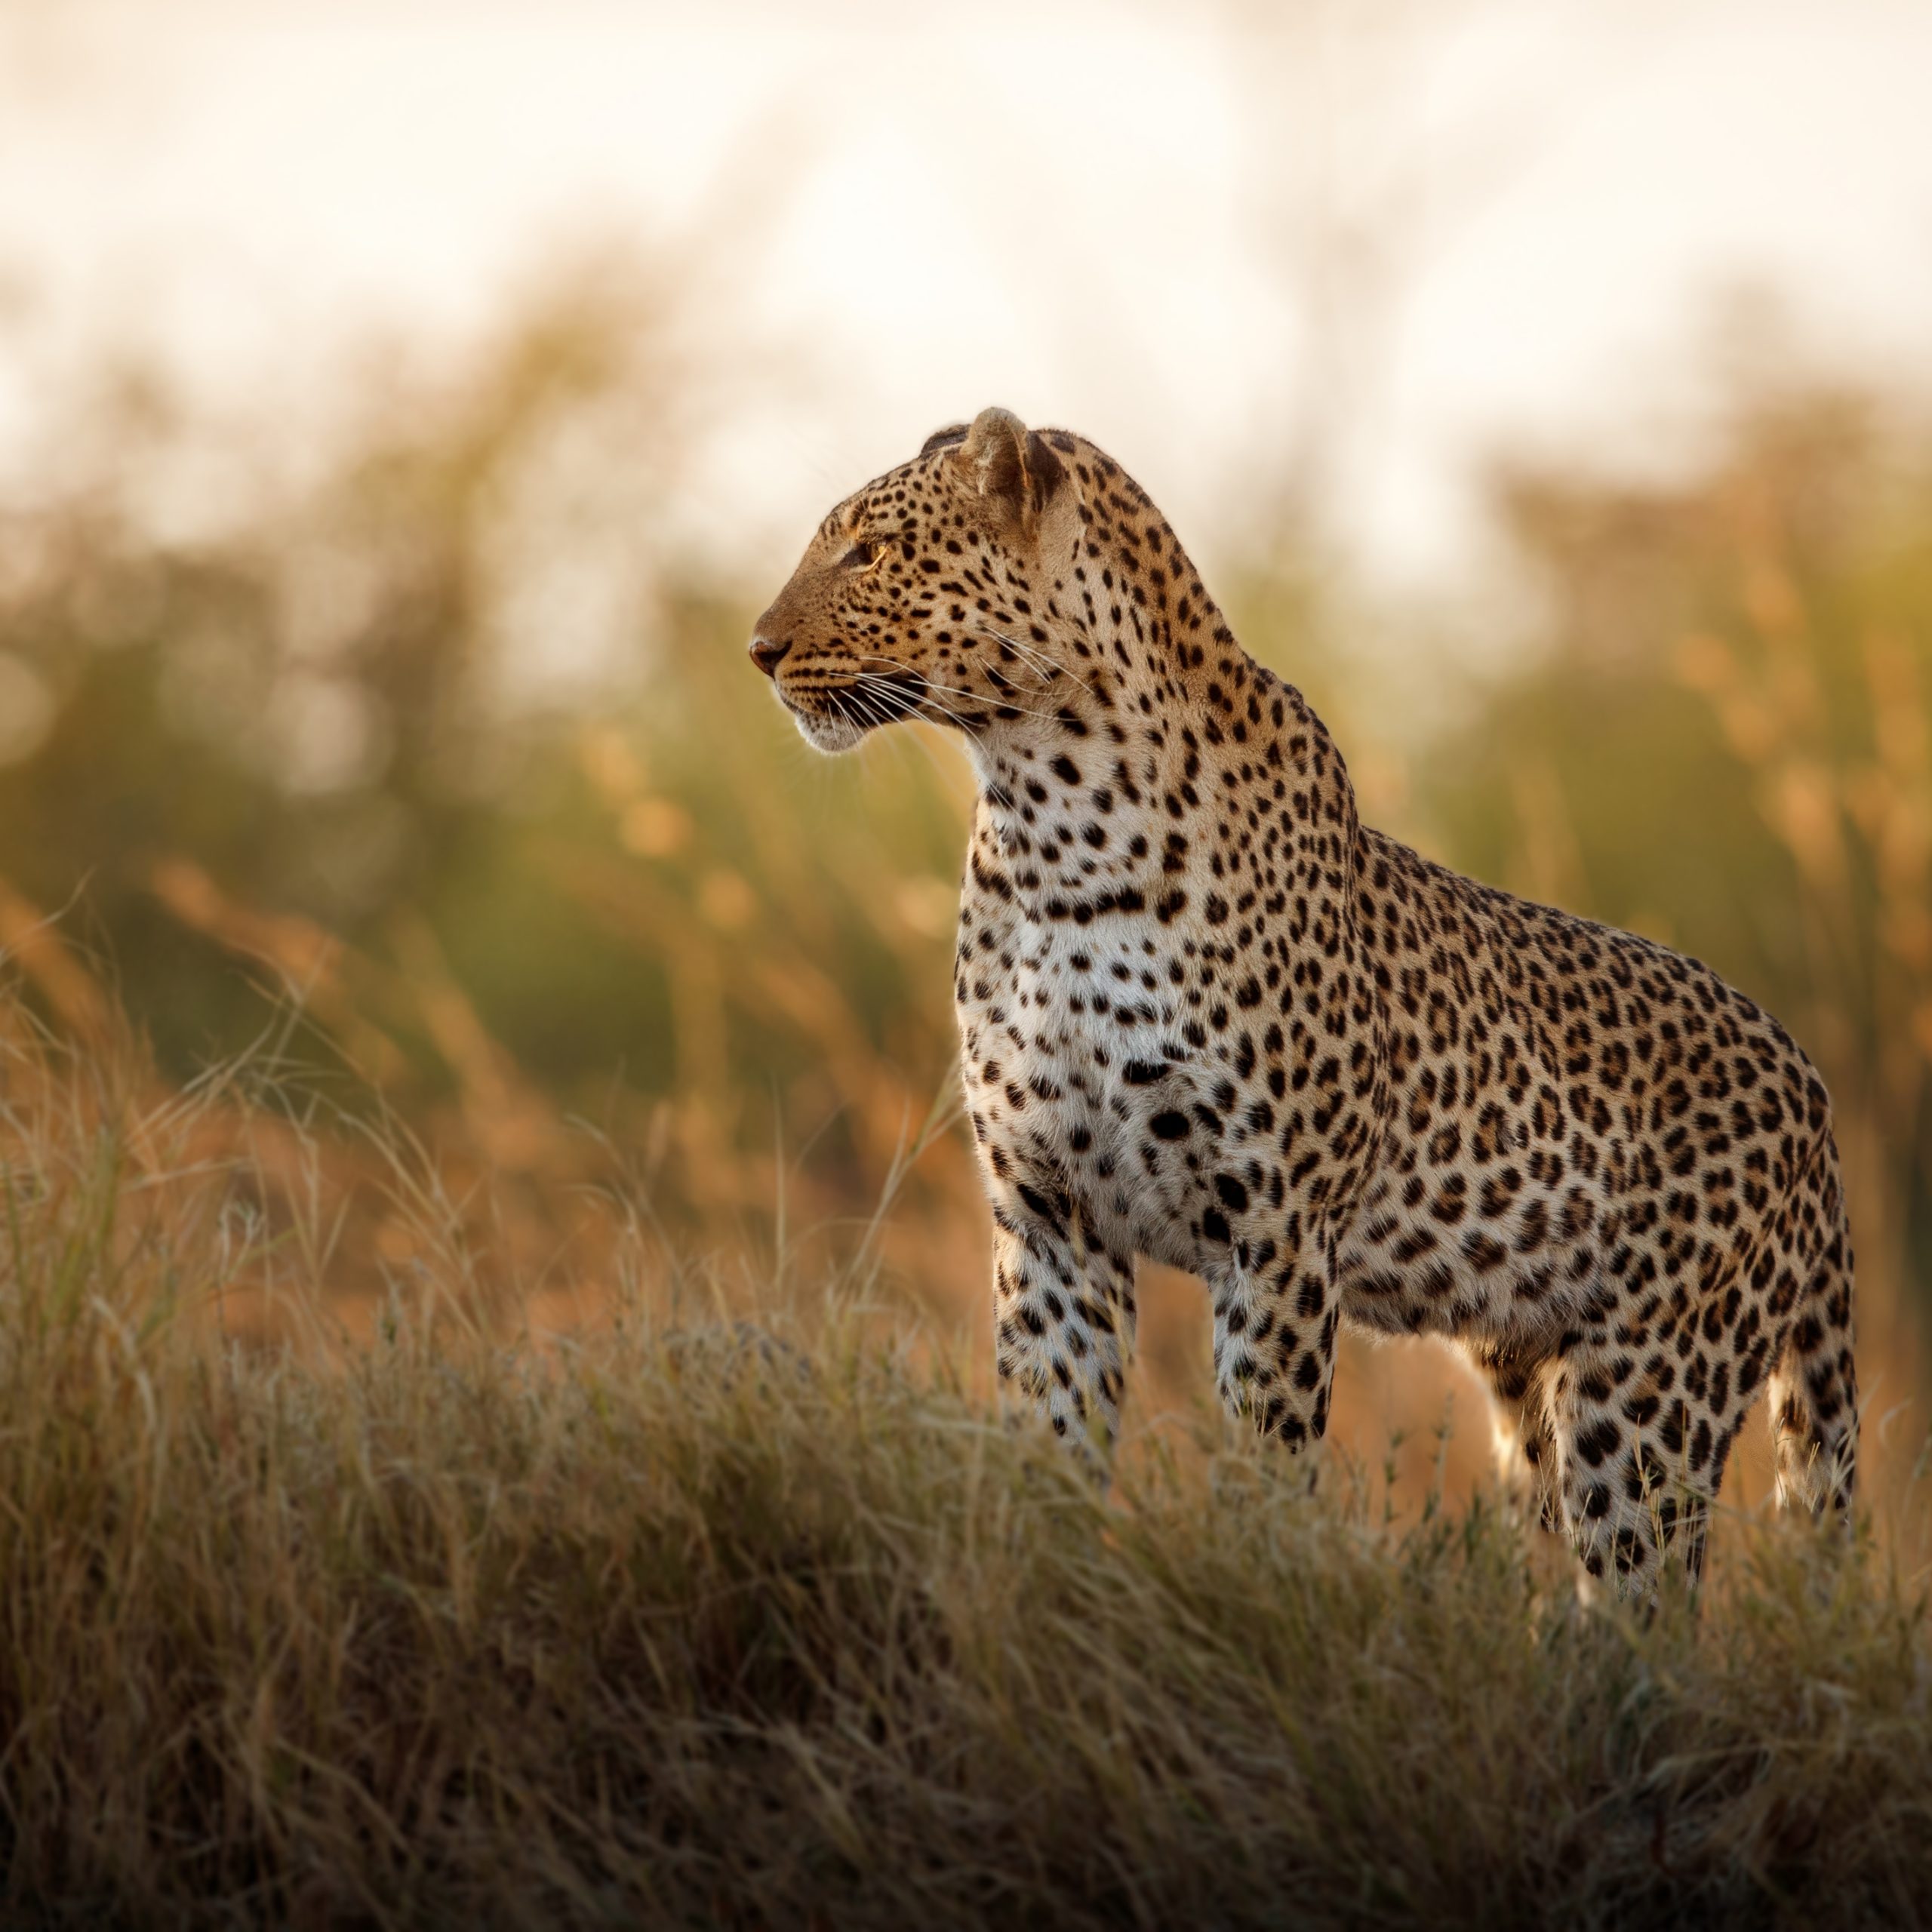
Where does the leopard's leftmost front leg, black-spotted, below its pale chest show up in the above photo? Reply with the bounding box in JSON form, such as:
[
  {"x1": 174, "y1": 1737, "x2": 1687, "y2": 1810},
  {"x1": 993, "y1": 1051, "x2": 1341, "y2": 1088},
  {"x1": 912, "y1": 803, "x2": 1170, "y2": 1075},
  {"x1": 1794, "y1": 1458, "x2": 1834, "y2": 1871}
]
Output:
[{"x1": 989, "y1": 1174, "x2": 1134, "y2": 1457}]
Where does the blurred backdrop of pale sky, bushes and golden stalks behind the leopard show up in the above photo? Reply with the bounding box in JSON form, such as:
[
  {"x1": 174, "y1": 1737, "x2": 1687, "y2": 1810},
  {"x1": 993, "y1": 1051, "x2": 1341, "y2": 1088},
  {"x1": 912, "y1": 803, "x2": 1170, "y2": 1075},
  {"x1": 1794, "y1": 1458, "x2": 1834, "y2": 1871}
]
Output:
[{"x1": 0, "y1": 0, "x2": 1932, "y2": 1494}]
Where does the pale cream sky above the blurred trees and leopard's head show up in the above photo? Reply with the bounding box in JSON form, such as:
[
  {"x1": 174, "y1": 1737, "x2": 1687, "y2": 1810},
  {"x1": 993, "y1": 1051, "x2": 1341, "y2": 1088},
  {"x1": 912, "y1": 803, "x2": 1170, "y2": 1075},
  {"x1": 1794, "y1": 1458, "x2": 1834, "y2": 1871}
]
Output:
[{"x1": 0, "y1": 0, "x2": 1932, "y2": 602}]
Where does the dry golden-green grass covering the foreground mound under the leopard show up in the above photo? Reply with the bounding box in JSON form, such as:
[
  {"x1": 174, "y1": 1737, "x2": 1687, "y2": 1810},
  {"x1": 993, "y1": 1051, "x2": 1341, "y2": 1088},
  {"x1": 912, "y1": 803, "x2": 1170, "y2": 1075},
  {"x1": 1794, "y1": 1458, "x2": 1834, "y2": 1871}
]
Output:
[{"x1": 0, "y1": 999, "x2": 1932, "y2": 1926}]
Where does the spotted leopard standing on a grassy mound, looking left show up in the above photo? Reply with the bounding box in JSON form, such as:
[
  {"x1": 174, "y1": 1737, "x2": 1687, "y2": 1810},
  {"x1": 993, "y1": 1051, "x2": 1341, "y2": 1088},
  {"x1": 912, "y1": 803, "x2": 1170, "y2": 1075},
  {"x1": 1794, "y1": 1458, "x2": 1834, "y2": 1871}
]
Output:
[{"x1": 749, "y1": 408, "x2": 1859, "y2": 1601}]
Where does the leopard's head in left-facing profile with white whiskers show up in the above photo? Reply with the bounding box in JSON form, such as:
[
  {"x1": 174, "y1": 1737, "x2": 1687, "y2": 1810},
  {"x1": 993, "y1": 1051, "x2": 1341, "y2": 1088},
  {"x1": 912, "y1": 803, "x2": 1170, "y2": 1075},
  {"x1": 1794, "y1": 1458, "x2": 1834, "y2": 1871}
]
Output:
[{"x1": 752, "y1": 410, "x2": 1088, "y2": 752}]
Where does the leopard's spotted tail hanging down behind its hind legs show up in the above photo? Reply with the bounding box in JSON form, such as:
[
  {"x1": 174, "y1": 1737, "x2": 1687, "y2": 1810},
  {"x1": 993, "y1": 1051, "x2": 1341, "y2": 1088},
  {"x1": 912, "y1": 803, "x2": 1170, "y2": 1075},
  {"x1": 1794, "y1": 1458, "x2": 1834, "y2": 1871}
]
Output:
[{"x1": 1770, "y1": 1126, "x2": 1859, "y2": 1522}]
